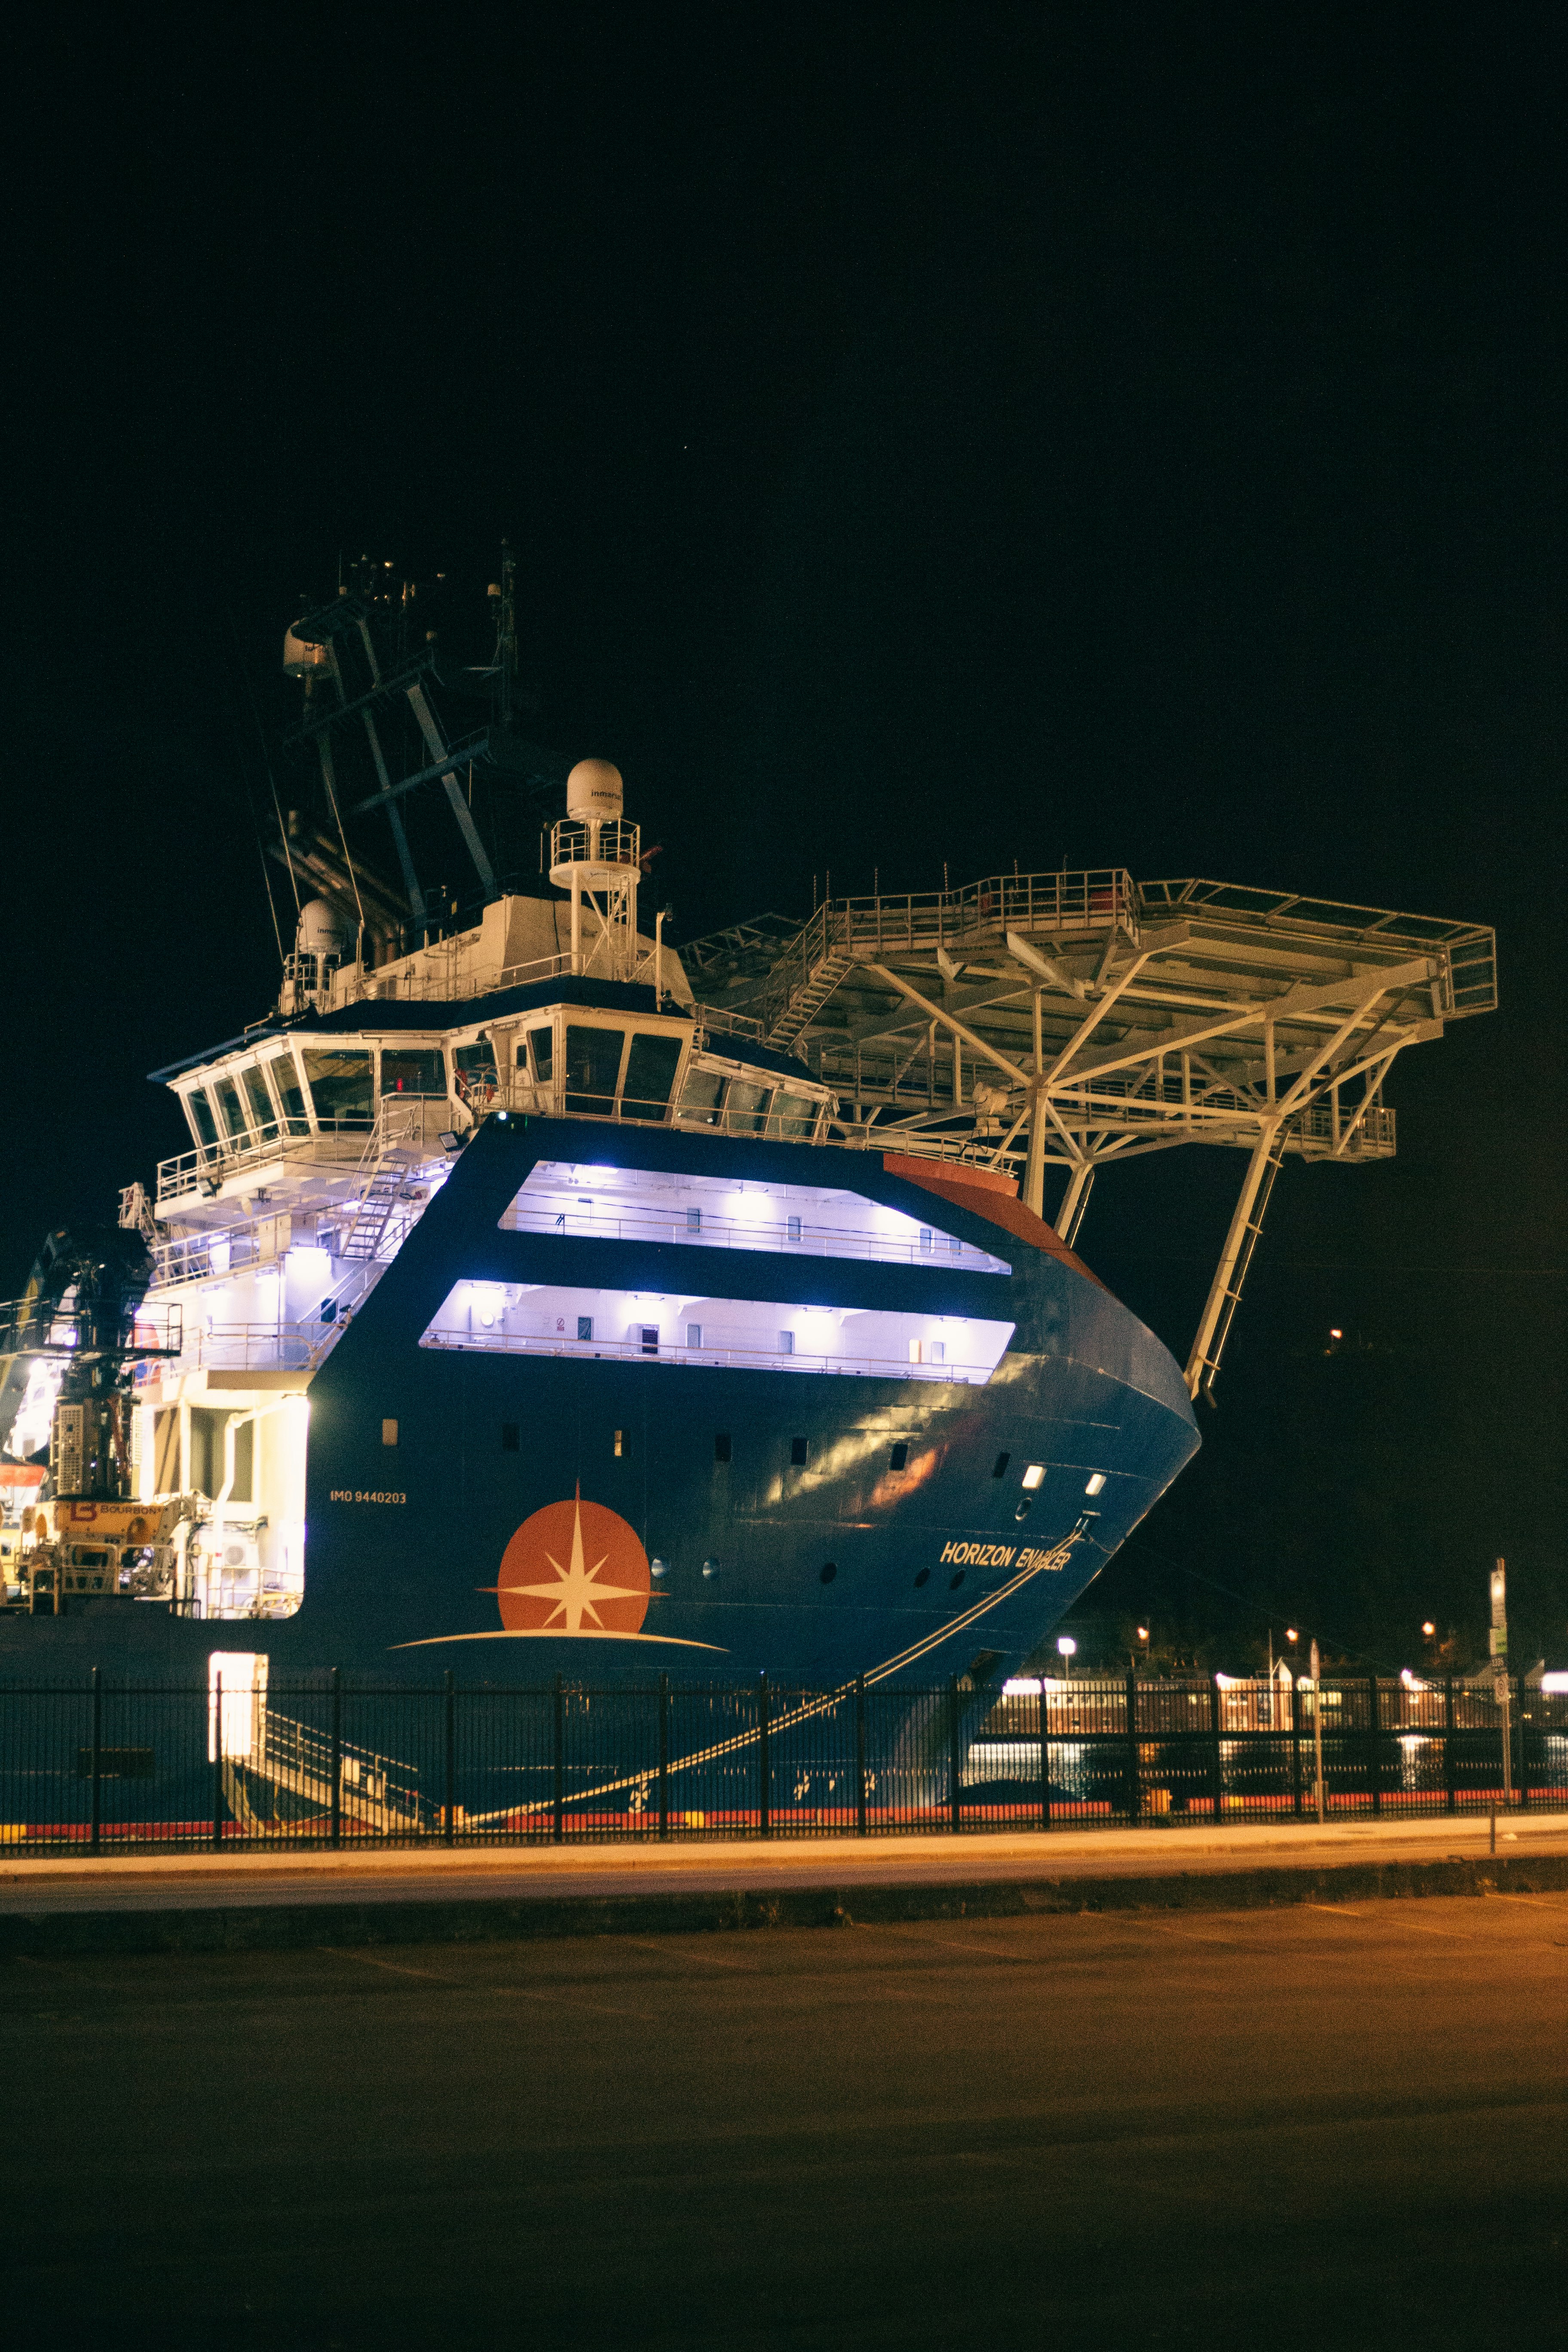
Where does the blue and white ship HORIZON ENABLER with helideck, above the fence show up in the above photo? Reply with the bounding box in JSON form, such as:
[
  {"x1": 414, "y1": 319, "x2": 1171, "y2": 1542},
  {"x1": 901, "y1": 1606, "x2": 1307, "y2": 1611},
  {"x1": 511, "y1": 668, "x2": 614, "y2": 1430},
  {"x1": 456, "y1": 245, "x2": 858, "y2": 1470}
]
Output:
[{"x1": 0, "y1": 555, "x2": 1495, "y2": 1708}]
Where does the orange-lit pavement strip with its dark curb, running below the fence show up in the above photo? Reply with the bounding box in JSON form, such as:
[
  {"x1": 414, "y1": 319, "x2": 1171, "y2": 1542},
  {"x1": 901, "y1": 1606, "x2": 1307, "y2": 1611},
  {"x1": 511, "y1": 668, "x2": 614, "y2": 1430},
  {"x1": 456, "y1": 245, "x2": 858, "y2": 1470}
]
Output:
[{"x1": 0, "y1": 1813, "x2": 1568, "y2": 1954}]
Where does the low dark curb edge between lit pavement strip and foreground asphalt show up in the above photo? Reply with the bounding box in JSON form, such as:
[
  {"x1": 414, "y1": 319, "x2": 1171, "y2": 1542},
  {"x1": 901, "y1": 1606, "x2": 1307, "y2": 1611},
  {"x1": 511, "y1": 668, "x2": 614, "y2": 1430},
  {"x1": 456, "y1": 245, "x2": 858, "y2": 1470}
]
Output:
[{"x1": 0, "y1": 1853, "x2": 1568, "y2": 1959}]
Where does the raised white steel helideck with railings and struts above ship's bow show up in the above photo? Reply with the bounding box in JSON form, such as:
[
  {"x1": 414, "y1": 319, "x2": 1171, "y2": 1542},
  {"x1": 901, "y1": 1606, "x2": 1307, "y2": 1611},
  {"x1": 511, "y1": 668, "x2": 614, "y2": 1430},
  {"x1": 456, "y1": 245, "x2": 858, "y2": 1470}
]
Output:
[{"x1": 698, "y1": 868, "x2": 1498, "y2": 1395}]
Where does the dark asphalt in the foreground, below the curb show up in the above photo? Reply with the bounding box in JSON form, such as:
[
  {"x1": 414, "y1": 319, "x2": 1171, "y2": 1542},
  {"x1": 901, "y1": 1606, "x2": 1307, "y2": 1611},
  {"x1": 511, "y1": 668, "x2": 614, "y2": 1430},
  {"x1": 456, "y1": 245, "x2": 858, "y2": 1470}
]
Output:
[{"x1": 0, "y1": 1893, "x2": 1568, "y2": 2352}]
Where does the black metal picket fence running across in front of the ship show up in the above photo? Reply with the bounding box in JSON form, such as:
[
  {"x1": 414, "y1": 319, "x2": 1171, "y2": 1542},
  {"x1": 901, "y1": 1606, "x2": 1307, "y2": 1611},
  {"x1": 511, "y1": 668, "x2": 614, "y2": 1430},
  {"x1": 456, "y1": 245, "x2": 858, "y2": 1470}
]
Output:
[{"x1": 0, "y1": 1668, "x2": 1568, "y2": 1853}]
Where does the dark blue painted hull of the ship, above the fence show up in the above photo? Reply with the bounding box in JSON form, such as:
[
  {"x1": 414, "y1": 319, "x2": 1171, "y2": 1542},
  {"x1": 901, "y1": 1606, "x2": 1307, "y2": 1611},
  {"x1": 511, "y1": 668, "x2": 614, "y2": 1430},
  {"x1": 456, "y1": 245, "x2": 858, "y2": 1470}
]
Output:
[{"x1": 0, "y1": 1120, "x2": 1199, "y2": 1689}]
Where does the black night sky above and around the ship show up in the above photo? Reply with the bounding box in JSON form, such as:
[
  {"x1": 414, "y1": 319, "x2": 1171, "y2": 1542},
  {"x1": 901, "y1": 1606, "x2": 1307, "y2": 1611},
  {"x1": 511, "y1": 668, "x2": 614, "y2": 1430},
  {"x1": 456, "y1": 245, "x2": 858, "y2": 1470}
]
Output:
[{"x1": 0, "y1": 14, "x2": 1568, "y2": 1663}]
